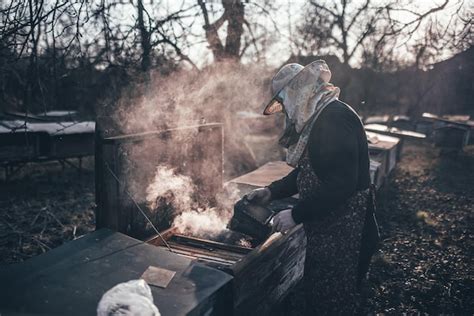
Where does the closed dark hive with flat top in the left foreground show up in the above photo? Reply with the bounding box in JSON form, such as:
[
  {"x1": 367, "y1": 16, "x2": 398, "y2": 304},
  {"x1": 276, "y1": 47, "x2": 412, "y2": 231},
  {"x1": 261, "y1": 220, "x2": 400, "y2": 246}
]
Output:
[{"x1": 0, "y1": 229, "x2": 232, "y2": 316}]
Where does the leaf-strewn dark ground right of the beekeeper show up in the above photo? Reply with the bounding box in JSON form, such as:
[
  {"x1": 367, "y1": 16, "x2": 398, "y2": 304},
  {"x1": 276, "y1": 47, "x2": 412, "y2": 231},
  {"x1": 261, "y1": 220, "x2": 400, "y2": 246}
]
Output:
[{"x1": 364, "y1": 146, "x2": 474, "y2": 315}]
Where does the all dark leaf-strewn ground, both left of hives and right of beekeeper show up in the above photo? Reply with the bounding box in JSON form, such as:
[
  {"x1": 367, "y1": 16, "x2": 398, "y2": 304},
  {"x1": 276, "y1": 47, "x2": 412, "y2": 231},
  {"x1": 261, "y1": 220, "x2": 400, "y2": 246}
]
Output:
[{"x1": 0, "y1": 145, "x2": 474, "y2": 315}]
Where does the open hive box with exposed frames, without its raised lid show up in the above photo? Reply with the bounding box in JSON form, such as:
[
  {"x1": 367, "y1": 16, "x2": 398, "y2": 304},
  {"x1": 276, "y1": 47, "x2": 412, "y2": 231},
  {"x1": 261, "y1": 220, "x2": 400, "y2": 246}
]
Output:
[{"x1": 148, "y1": 225, "x2": 306, "y2": 315}]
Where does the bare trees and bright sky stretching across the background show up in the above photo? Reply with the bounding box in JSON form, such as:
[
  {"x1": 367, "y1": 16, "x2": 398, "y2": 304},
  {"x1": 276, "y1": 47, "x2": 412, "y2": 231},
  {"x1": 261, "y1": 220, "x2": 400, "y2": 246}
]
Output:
[{"x1": 0, "y1": 0, "x2": 473, "y2": 115}]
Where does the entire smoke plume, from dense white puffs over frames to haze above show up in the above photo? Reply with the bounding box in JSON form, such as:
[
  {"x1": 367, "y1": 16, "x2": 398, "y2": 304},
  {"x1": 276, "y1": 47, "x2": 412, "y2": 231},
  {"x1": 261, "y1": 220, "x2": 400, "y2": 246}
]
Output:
[{"x1": 107, "y1": 63, "x2": 283, "y2": 237}]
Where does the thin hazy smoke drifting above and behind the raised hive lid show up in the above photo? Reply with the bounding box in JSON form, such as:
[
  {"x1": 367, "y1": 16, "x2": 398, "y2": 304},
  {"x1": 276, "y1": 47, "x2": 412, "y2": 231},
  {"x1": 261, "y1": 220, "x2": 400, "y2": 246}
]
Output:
[{"x1": 113, "y1": 63, "x2": 282, "y2": 179}]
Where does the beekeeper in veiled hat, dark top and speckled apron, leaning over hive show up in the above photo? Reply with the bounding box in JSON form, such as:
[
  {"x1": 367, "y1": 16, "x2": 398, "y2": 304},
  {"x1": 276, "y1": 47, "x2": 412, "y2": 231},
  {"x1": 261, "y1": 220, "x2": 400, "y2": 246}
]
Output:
[{"x1": 248, "y1": 60, "x2": 378, "y2": 315}]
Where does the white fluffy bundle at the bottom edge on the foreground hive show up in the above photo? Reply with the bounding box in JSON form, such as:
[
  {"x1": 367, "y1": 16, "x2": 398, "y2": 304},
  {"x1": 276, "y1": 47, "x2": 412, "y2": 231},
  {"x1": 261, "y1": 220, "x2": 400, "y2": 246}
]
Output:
[{"x1": 97, "y1": 279, "x2": 160, "y2": 316}]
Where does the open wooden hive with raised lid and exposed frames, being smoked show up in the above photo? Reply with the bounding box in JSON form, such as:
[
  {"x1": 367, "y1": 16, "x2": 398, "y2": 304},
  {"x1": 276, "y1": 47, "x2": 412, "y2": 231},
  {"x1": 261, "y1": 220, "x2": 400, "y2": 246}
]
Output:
[{"x1": 96, "y1": 124, "x2": 306, "y2": 315}]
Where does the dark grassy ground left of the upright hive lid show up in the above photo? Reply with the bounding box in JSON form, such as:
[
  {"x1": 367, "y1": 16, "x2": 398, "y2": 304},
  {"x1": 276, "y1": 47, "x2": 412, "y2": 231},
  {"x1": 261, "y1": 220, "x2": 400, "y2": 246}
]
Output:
[{"x1": 0, "y1": 158, "x2": 95, "y2": 264}]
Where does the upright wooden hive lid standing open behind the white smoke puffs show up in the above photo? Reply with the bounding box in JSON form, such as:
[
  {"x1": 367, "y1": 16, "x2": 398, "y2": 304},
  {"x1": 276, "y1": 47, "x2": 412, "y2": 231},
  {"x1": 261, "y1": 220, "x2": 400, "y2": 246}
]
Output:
[{"x1": 95, "y1": 123, "x2": 223, "y2": 238}]
